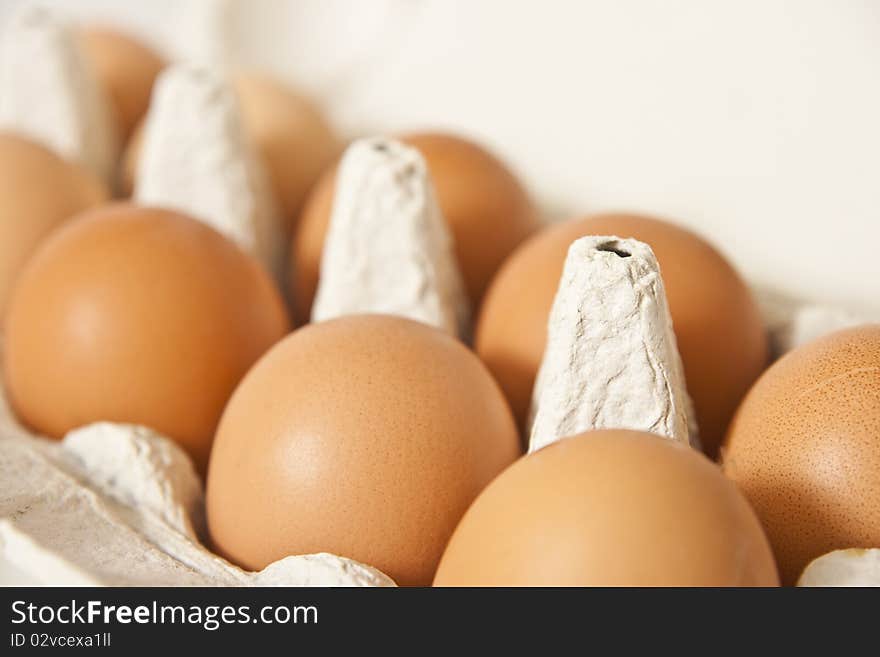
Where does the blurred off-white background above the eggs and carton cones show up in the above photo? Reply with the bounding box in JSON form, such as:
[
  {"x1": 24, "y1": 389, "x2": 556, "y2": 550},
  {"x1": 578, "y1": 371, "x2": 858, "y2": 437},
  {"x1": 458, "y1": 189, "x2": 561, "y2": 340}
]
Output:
[{"x1": 0, "y1": 0, "x2": 880, "y2": 310}]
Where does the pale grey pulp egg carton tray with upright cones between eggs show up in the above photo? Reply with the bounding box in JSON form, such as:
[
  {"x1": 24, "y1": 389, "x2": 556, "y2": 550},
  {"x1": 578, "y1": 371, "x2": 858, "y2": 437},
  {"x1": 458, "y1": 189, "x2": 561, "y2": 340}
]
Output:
[{"x1": 0, "y1": 5, "x2": 878, "y2": 586}]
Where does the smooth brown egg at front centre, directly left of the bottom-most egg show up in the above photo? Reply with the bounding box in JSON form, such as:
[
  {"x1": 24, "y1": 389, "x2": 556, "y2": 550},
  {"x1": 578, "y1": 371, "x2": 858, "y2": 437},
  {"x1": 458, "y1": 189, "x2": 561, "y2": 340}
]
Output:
[{"x1": 207, "y1": 315, "x2": 519, "y2": 585}]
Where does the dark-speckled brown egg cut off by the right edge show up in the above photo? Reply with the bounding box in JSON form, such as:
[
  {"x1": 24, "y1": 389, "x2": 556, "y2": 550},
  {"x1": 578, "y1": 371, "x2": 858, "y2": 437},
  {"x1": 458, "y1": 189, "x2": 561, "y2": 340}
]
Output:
[{"x1": 722, "y1": 325, "x2": 880, "y2": 584}]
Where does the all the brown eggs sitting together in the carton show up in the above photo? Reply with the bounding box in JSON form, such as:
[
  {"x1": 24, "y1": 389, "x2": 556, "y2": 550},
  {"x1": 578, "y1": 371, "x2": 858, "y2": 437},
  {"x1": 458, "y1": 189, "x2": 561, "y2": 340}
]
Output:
[{"x1": 0, "y1": 31, "x2": 880, "y2": 585}]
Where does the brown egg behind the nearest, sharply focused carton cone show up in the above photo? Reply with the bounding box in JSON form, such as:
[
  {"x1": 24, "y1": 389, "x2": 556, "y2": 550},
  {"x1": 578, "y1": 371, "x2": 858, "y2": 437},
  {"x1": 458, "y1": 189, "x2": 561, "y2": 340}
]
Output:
[{"x1": 475, "y1": 214, "x2": 767, "y2": 458}]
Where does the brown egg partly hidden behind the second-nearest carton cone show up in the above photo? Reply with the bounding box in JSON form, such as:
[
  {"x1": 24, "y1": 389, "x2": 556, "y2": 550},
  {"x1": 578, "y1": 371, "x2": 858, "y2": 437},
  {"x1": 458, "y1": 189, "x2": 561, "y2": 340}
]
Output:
[{"x1": 291, "y1": 133, "x2": 540, "y2": 321}]
